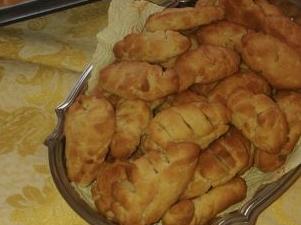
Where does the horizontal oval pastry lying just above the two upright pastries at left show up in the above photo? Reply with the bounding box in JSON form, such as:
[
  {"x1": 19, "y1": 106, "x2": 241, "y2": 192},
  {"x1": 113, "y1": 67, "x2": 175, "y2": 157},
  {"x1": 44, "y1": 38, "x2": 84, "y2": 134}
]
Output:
[{"x1": 98, "y1": 61, "x2": 178, "y2": 101}]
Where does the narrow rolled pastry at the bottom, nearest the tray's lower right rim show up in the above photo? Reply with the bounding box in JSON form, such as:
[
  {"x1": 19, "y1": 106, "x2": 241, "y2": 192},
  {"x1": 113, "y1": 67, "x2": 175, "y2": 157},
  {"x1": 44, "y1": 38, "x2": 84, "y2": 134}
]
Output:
[{"x1": 162, "y1": 177, "x2": 247, "y2": 225}]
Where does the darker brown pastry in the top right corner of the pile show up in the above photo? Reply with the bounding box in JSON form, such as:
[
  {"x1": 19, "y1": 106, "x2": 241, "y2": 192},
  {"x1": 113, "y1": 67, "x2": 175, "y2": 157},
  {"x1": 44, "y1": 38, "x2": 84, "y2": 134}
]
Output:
[{"x1": 221, "y1": 0, "x2": 301, "y2": 53}]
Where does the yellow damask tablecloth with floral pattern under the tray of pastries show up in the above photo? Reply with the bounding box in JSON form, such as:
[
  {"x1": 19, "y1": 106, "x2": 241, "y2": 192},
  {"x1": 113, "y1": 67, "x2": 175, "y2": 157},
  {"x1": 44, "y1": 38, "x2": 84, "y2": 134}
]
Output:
[{"x1": 0, "y1": 1, "x2": 301, "y2": 225}]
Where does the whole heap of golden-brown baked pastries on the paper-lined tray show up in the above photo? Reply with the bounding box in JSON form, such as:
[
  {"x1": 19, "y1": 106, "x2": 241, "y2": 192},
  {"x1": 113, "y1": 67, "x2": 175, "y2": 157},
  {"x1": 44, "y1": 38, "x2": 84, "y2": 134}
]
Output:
[{"x1": 65, "y1": 0, "x2": 301, "y2": 225}]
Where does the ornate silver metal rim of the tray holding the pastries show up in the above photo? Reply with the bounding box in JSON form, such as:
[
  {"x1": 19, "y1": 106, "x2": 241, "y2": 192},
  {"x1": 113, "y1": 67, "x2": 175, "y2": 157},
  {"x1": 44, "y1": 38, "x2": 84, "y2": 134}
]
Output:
[{"x1": 45, "y1": 65, "x2": 301, "y2": 225}]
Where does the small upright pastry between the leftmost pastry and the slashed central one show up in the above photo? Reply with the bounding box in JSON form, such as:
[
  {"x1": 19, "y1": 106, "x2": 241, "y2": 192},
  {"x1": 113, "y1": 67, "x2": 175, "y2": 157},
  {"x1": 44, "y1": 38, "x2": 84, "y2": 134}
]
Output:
[{"x1": 110, "y1": 100, "x2": 151, "y2": 159}]
